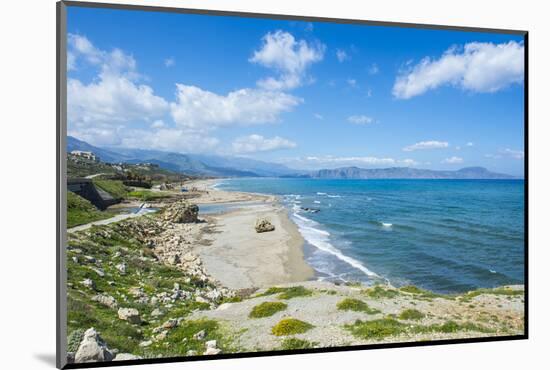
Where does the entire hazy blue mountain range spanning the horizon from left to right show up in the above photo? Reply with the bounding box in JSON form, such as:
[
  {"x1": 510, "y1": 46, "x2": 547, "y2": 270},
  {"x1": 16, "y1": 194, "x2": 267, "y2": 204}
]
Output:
[{"x1": 67, "y1": 136, "x2": 519, "y2": 179}]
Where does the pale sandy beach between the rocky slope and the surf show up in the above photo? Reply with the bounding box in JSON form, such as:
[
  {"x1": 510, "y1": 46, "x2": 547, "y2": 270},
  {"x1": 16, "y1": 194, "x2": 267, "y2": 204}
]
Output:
[{"x1": 186, "y1": 180, "x2": 314, "y2": 289}]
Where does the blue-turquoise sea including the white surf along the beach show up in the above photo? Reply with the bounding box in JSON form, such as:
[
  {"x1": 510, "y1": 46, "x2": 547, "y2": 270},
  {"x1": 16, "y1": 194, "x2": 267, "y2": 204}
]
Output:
[{"x1": 217, "y1": 178, "x2": 524, "y2": 292}]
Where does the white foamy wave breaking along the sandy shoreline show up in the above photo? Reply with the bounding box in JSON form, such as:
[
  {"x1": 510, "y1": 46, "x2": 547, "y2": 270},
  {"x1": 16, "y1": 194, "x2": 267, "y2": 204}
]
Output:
[{"x1": 293, "y1": 213, "x2": 380, "y2": 277}]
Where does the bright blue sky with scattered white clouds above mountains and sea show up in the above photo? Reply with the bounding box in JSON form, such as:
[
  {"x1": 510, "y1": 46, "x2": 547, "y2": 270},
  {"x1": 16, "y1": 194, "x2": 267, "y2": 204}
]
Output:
[{"x1": 68, "y1": 7, "x2": 524, "y2": 175}]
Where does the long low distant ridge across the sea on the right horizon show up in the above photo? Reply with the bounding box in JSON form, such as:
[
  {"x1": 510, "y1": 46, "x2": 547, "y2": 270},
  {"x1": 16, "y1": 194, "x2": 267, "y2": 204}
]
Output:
[{"x1": 310, "y1": 167, "x2": 518, "y2": 179}]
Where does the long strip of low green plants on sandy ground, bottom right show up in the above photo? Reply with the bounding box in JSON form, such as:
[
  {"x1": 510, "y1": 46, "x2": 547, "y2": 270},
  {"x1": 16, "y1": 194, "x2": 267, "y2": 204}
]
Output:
[{"x1": 344, "y1": 317, "x2": 495, "y2": 340}]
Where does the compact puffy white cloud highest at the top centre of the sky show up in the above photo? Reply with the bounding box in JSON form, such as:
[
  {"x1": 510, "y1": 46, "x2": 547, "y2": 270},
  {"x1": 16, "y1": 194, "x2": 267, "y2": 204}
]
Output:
[{"x1": 249, "y1": 30, "x2": 326, "y2": 90}]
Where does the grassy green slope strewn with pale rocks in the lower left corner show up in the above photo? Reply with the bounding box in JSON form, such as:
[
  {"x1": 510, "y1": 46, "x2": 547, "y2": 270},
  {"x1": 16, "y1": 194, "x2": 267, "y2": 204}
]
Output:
[{"x1": 67, "y1": 217, "x2": 230, "y2": 357}]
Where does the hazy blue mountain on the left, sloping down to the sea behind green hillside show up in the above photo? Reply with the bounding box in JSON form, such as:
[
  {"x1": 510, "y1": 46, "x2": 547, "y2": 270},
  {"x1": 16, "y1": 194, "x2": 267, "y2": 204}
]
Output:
[{"x1": 67, "y1": 136, "x2": 300, "y2": 177}]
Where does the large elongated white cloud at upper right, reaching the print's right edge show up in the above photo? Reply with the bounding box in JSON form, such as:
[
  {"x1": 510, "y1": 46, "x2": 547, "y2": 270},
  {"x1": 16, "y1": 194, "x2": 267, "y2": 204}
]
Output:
[{"x1": 393, "y1": 41, "x2": 524, "y2": 99}]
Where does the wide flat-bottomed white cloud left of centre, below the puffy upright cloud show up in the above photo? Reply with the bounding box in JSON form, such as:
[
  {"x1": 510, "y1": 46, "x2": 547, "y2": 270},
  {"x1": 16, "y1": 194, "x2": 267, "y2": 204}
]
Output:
[{"x1": 170, "y1": 84, "x2": 302, "y2": 130}]
